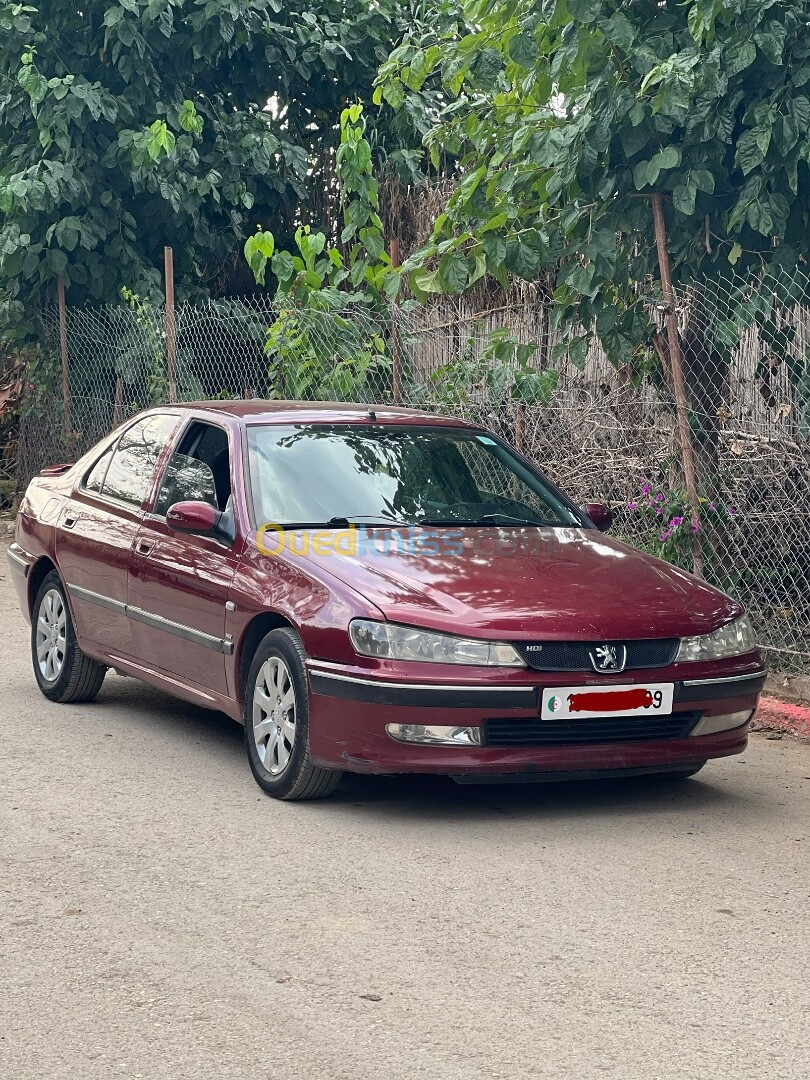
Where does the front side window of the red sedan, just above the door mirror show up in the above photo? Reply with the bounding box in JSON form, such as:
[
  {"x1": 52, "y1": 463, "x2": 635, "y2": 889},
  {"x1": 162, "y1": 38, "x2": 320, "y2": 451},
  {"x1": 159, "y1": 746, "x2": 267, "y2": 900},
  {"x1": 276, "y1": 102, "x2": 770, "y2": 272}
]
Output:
[{"x1": 154, "y1": 421, "x2": 231, "y2": 517}]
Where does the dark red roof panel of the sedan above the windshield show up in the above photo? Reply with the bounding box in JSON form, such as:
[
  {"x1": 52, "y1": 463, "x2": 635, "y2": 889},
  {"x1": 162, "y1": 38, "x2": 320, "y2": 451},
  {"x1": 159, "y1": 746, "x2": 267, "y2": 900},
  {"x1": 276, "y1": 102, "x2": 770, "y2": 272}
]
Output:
[{"x1": 172, "y1": 399, "x2": 477, "y2": 428}]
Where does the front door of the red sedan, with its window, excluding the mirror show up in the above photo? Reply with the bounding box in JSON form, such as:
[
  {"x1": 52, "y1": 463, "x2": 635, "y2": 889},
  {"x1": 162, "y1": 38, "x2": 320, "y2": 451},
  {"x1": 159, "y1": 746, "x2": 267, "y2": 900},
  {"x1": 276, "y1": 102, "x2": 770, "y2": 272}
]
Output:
[{"x1": 129, "y1": 420, "x2": 241, "y2": 694}]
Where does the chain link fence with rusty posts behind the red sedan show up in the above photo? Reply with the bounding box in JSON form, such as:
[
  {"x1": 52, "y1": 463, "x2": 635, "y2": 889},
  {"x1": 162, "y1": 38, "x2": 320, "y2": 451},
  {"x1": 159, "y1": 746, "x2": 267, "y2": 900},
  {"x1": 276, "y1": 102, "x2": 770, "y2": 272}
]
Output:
[{"x1": 18, "y1": 269, "x2": 810, "y2": 673}]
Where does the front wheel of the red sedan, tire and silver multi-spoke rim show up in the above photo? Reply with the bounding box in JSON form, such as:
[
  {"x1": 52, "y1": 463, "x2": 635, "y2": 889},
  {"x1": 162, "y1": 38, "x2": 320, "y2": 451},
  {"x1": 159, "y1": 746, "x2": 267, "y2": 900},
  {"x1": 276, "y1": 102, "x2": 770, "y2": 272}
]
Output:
[{"x1": 244, "y1": 627, "x2": 341, "y2": 800}]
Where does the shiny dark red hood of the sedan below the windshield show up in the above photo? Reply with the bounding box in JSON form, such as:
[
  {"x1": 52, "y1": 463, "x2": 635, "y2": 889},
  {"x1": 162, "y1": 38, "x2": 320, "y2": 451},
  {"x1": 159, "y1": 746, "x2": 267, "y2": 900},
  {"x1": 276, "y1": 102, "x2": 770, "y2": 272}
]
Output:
[{"x1": 303, "y1": 528, "x2": 742, "y2": 640}]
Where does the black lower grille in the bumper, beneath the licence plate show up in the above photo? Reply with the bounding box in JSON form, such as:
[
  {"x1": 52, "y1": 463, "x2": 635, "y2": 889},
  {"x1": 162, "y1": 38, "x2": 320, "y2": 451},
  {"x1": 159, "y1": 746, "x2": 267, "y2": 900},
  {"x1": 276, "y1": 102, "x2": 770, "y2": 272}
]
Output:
[{"x1": 484, "y1": 713, "x2": 702, "y2": 746}]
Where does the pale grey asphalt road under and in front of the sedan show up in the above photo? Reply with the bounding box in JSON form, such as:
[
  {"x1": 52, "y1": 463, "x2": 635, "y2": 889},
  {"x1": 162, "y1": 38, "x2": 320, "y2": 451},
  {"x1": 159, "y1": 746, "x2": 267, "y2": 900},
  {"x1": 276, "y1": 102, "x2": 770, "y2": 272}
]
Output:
[{"x1": 0, "y1": 567, "x2": 810, "y2": 1080}]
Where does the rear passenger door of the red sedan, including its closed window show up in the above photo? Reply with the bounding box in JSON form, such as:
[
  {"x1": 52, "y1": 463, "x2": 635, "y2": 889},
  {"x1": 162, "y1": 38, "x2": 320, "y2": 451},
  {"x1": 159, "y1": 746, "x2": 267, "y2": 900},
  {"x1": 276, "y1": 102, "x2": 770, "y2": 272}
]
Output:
[{"x1": 55, "y1": 413, "x2": 179, "y2": 656}]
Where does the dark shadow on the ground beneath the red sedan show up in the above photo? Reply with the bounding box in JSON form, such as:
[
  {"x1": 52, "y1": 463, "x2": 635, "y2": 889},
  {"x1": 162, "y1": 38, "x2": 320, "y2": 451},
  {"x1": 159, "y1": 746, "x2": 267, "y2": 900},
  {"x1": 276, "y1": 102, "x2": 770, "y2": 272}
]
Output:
[{"x1": 90, "y1": 677, "x2": 762, "y2": 823}]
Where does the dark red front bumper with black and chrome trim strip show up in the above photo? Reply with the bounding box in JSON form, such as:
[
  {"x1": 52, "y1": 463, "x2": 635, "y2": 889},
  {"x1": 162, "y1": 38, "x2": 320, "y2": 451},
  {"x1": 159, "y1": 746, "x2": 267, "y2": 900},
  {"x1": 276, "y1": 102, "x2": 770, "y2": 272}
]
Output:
[{"x1": 308, "y1": 660, "x2": 765, "y2": 779}]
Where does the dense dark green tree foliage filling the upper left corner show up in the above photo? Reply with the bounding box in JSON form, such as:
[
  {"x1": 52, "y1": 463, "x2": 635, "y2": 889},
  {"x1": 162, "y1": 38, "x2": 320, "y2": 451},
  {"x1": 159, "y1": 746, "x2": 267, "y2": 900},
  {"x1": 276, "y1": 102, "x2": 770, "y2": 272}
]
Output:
[{"x1": 0, "y1": 0, "x2": 438, "y2": 333}]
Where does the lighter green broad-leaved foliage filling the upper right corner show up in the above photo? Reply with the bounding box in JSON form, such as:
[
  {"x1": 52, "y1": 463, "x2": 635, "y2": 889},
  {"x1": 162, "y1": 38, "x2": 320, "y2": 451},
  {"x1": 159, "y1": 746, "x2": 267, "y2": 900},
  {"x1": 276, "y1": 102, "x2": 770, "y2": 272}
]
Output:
[{"x1": 377, "y1": 0, "x2": 810, "y2": 362}]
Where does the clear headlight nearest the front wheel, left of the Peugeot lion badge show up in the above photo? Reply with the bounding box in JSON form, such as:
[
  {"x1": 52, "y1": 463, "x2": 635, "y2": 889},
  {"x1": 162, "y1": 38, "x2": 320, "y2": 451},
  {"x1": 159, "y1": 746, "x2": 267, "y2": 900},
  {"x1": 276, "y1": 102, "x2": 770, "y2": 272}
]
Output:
[{"x1": 349, "y1": 619, "x2": 526, "y2": 667}]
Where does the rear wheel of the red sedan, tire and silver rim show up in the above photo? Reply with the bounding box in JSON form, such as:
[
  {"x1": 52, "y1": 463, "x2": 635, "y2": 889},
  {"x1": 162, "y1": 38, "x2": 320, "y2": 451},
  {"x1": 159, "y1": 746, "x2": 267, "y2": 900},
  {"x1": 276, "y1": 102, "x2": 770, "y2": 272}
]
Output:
[{"x1": 31, "y1": 570, "x2": 107, "y2": 703}]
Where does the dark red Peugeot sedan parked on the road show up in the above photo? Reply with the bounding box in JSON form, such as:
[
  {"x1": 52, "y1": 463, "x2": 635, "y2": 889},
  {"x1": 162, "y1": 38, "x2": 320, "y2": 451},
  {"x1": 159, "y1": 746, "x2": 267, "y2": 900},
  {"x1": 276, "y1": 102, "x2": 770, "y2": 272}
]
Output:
[{"x1": 9, "y1": 402, "x2": 765, "y2": 799}]
